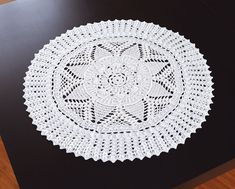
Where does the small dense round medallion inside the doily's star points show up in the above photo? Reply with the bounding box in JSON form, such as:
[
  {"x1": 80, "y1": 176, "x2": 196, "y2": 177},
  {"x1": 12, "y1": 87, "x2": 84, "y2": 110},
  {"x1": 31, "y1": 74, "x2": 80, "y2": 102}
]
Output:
[{"x1": 84, "y1": 56, "x2": 151, "y2": 106}]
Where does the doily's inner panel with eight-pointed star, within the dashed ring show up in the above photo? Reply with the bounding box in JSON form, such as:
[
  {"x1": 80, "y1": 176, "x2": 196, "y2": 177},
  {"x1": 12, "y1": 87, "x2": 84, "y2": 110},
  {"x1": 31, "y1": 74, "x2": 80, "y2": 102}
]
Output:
[{"x1": 51, "y1": 37, "x2": 183, "y2": 133}]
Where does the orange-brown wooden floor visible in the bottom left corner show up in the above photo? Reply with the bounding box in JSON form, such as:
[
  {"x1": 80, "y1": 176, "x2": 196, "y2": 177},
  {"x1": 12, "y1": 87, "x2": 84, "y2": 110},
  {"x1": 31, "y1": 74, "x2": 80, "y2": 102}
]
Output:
[{"x1": 0, "y1": 137, "x2": 19, "y2": 189}]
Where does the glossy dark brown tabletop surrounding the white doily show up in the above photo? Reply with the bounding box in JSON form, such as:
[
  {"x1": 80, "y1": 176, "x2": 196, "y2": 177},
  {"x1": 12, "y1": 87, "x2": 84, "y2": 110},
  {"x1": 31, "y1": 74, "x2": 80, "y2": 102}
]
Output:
[{"x1": 0, "y1": 0, "x2": 235, "y2": 189}]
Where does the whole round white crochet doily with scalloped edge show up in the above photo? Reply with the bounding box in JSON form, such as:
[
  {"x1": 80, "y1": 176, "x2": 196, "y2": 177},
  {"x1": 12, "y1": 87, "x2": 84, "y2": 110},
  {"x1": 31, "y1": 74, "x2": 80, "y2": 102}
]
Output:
[{"x1": 24, "y1": 20, "x2": 213, "y2": 162}]
